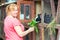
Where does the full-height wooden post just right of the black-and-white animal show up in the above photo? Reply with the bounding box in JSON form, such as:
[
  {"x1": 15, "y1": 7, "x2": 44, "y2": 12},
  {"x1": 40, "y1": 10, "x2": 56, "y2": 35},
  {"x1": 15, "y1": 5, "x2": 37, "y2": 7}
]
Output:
[{"x1": 38, "y1": 0, "x2": 44, "y2": 40}]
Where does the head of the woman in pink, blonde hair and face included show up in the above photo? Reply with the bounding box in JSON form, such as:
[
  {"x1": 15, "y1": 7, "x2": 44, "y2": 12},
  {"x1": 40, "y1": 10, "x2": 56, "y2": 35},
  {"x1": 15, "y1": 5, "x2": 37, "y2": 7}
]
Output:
[{"x1": 6, "y1": 4, "x2": 18, "y2": 16}]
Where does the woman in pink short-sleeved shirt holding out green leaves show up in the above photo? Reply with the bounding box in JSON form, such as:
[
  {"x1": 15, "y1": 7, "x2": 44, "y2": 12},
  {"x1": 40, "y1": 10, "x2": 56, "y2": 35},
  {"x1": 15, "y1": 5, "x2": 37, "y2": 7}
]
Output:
[{"x1": 4, "y1": 4, "x2": 34, "y2": 40}]
